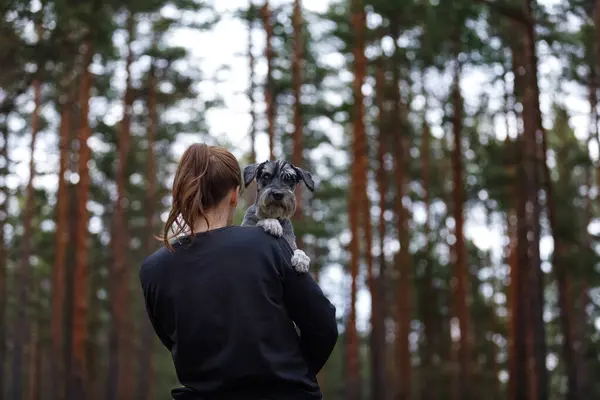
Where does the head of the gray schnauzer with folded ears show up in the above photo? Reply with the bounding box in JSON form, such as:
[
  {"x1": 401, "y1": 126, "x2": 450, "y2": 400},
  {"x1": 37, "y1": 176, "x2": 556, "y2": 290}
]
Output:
[{"x1": 244, "y1": 160, "x2": 315, "y2": 218}]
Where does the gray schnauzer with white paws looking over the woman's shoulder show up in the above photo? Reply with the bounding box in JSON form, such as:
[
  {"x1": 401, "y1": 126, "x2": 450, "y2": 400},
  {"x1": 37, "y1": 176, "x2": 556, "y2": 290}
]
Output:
[{"x1": 242, "y1": 160, "x2": 315, "y2": 273}]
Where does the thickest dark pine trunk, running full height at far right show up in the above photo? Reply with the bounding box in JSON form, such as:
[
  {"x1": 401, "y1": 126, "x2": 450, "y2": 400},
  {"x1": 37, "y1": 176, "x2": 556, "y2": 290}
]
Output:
[{"x1": 523, "y1": 0, "x2": 548, "y2": 400}]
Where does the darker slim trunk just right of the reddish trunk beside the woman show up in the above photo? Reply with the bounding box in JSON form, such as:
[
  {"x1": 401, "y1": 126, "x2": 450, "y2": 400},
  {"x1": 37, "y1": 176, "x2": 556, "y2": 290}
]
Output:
[{"x1": 372, "y1": 59, "x2": 389, "y2": 399}]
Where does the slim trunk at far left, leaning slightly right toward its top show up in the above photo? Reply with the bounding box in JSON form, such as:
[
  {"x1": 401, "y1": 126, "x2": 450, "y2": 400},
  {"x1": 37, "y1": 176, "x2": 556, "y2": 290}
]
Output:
[{"x1": 10, "y1": 80, "x2": 41, "y2": 400}]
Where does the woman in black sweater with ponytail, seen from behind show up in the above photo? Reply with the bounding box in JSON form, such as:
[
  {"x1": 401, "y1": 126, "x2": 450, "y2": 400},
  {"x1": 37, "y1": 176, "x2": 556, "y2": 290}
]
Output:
[{"x1": 139, "y1": 144, "x2": 338, "y2": 400}]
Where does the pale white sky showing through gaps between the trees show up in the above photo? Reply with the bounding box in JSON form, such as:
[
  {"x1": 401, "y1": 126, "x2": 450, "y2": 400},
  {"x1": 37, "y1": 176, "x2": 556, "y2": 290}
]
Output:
[{"x1": 8, "y1": 0, "x2": 598, "y2": 330}]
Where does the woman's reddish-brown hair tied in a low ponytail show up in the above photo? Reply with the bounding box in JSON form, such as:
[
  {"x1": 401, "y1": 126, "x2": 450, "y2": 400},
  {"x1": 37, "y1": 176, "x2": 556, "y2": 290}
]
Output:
[{"x1": 160, "y1": 143, "x2": 242, "y2": 251}]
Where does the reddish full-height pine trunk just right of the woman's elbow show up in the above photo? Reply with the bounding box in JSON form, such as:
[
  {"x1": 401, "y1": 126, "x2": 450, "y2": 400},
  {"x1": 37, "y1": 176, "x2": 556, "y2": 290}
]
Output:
[{"x1": 345, "y1": 0, "x2": 366, "y2": 400}]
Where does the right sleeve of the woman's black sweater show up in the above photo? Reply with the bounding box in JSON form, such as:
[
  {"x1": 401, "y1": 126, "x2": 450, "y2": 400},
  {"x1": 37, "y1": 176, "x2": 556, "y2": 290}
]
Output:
[{"x1": 279, "y1": 239, "x2": 338, "y2": 375}]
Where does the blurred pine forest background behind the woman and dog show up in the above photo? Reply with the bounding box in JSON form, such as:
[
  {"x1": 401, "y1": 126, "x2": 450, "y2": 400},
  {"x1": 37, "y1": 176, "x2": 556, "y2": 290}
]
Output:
[{"x1": 0, "y1": 0, "x2": 600, "y2": 400}]
